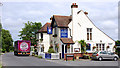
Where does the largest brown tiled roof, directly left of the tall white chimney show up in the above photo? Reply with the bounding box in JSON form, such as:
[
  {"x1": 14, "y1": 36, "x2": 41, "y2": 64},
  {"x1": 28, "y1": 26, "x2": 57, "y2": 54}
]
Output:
[{"x1": 53, "y1": 15, "x2": 71, "y2": 27}]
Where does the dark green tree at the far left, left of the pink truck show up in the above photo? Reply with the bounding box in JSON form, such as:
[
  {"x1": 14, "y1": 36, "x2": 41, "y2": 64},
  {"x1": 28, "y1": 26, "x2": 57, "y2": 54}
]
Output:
[{"x1": 2, "y1": 29, "x2": 13, "y2": 52}]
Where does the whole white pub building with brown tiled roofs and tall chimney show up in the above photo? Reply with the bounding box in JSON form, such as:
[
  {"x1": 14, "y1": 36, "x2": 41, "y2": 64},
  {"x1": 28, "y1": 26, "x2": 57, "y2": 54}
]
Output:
[{"x1": 36, "y1": 3, "x2": 115, "y2": 59}]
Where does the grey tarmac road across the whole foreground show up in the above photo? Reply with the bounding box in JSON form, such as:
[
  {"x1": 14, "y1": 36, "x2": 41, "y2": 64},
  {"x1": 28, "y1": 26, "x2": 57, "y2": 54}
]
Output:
[{"x1": 2, "y1": 52, "x2": 118, "y2": 66}]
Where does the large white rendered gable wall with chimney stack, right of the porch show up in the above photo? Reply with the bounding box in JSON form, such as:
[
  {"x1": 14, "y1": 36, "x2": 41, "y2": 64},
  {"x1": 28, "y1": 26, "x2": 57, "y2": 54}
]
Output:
[{"x1": 68, "y1": 8, "x2": 115, "y2": 52}]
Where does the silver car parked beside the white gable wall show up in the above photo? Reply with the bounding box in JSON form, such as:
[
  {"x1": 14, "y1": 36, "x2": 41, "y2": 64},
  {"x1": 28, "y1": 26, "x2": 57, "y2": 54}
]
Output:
[{"x1": 92, "y1": 51, "x2": 119, "y2": 61}]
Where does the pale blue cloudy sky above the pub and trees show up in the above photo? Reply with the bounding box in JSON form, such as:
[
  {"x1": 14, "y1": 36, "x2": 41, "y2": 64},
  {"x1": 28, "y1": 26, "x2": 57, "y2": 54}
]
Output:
[{"x1": 0, "y1": 0, "x2": 118, "y2": 41}]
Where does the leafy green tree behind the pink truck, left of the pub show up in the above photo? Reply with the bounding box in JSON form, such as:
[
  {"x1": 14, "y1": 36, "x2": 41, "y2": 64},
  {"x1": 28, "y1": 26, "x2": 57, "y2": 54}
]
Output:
[{"x1": 18, "y1": 21, "x2": 42, "y2": 45}]
